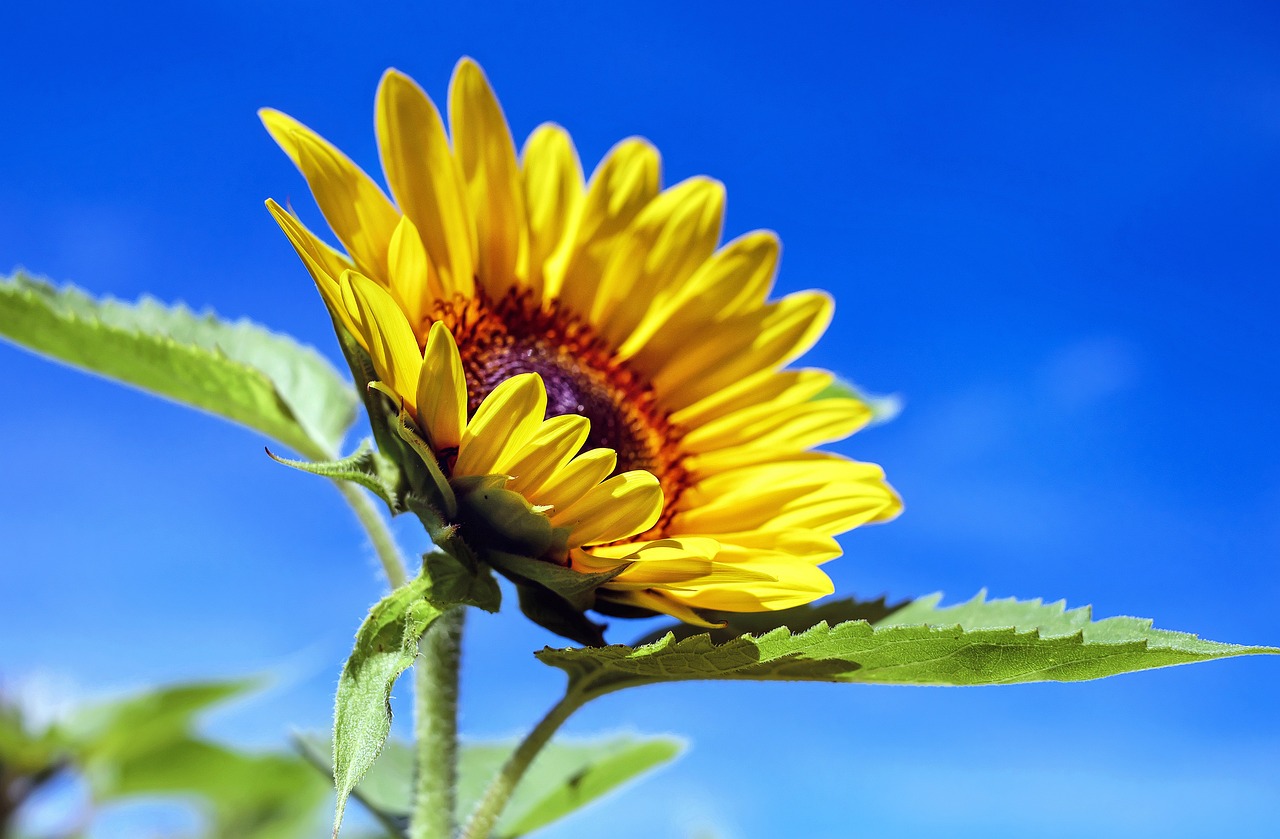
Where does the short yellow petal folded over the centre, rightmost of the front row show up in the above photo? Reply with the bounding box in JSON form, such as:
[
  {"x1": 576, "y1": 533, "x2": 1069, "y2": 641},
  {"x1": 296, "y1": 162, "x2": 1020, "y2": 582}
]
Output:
[{"x1": 552, "y1": 470, "x2": 662, "y2": 548}]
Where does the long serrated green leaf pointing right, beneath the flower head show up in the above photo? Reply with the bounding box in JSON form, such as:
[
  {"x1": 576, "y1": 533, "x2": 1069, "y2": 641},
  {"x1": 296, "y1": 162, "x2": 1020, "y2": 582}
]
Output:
[{"x1": 538, "y1": 594, "x2": 1280, "y2": 697}]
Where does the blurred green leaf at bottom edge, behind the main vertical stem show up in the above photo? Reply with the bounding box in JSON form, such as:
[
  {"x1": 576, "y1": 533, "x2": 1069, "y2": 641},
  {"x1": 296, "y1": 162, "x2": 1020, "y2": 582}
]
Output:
[{"x1": 298, "y1": 735, "x2": 684, "y2": 839}]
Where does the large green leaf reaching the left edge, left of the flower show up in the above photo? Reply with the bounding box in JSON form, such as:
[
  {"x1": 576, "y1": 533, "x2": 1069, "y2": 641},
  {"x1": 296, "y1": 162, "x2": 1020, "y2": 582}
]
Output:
[{"x1": 0, "y1": 274, "x2": 356, "y2": 459}]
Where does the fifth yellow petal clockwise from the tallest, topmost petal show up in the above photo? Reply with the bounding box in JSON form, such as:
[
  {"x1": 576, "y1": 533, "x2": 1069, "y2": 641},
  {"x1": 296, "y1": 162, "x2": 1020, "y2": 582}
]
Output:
[{"x1": 653, "y1": 292, "x2": 832, "y2": 410}]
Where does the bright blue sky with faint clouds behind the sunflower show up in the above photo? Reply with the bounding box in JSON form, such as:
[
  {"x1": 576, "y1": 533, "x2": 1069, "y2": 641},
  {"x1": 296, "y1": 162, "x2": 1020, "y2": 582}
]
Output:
[{"x1": 0, "y1": 3, "x2": 1280, "y2": 839}]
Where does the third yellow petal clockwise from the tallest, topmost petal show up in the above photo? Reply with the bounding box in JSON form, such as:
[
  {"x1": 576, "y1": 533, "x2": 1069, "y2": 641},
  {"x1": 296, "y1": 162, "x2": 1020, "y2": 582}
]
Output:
[{"x1": 590, "y1": 177, "x2": 724, "y2": 348}]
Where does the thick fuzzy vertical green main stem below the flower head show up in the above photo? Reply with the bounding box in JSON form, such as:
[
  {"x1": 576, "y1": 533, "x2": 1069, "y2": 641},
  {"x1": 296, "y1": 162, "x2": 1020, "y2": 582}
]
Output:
[{"x1": 408, "y1": 606, "x2": 466, "y2": 839}]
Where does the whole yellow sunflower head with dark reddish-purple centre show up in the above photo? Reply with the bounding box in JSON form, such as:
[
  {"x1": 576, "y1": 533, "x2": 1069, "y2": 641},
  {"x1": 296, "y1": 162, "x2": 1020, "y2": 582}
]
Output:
[{"x1": 261, "y1": 59, "x2": 901, "y2": 625}]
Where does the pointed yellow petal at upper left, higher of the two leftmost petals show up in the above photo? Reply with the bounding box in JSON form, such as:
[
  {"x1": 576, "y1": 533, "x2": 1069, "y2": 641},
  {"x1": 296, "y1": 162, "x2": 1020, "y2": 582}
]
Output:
[{"x1": 259, "y1": 108, "x2": 399, "y2": 284}]
